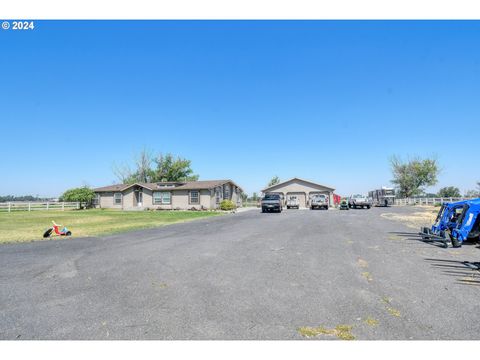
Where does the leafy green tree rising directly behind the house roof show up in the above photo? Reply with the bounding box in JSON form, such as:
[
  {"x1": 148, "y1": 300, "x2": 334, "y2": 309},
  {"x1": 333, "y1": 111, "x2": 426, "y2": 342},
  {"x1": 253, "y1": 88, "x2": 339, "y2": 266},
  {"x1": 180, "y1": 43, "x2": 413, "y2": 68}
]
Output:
[{"x1": 153, "y1": 154, "x2": 198, "y2": 182}]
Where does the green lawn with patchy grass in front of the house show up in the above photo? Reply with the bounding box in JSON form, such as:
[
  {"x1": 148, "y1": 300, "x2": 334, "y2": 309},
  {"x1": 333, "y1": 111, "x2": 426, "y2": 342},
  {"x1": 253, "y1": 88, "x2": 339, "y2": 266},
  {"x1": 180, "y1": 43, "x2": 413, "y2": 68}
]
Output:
[{"x1": 0, "y1": 210, "x2": 221, "y2": 243}]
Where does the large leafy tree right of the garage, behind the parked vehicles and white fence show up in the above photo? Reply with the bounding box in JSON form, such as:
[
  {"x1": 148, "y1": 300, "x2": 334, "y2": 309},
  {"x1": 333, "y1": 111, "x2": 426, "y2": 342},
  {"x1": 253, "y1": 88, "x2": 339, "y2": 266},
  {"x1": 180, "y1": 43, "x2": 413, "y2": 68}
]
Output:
[{"x1": 390, "y1": 156, "x2": 440, "y2": 197}]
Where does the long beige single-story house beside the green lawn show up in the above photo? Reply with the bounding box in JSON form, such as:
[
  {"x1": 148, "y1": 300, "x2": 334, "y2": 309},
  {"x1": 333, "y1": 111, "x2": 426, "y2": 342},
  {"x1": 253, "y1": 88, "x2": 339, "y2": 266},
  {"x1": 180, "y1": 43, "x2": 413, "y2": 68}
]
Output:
[{"x1": 93, "y1": 180, "x2": 243, "y2": 210}]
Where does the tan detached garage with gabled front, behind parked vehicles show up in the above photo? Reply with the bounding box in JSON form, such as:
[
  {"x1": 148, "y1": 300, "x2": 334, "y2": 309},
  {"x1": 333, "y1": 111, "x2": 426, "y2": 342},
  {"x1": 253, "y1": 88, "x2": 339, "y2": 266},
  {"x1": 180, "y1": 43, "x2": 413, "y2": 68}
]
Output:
[{"x1": 262, "y1": 178, "x2": 335, "y2": 207}]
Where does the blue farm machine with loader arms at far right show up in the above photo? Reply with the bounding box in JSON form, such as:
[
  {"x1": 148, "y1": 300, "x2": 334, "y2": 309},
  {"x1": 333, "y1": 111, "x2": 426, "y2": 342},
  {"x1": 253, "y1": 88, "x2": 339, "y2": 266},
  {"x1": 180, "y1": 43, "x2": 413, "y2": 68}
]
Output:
[{"x1": 419, "y1": 199, "x2": 480, "y2": 247}]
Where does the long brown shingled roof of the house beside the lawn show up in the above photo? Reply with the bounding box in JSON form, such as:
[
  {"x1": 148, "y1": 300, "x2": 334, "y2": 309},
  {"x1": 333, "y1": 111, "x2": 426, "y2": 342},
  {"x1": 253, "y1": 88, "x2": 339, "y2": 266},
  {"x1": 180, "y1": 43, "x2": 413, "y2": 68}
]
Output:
[{"x1": 93, "y1": 180, "x2": 243, "y2": 192}]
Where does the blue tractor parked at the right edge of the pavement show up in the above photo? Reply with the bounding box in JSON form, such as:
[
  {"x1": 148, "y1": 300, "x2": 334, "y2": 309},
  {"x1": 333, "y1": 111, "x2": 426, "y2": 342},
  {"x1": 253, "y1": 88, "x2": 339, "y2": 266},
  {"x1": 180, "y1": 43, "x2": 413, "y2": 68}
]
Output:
[{"x1": 419, "y1": 199, "x2": 480, "y2": 247}]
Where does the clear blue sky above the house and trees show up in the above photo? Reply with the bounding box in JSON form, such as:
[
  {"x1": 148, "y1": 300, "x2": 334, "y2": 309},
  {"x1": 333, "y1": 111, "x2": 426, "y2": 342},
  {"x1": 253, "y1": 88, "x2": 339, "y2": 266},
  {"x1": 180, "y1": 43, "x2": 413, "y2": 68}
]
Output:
[{"x1": 0, "y1": 21, "x2": 480, "y2": 196}]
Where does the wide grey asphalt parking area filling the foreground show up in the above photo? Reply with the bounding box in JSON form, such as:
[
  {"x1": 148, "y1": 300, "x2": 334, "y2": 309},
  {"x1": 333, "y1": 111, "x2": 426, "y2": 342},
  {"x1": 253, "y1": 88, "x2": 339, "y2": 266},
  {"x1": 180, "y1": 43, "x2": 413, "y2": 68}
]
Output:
[{"x1": 0, "y1": 208, "x2": 480, "y2": 339}]
